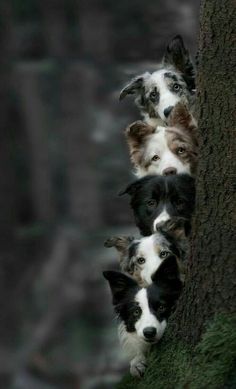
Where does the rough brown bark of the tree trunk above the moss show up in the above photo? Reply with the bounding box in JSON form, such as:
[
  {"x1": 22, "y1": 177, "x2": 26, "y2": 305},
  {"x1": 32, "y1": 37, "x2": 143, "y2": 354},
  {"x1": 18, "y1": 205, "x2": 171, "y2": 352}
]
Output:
[{"x1": 171, "y1": 0, "x2": 236, "y2": 344}]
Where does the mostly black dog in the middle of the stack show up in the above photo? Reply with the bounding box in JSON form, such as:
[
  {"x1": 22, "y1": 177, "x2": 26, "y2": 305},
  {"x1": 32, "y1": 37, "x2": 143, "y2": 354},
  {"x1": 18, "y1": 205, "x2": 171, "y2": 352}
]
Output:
[{"x1": 119, "y1": 174, "x2": 195, "y2": 236}]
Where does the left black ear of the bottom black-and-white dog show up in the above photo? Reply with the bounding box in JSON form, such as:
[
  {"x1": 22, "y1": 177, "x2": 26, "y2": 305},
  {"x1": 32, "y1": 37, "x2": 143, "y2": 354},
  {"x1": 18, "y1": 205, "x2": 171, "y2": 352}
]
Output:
[{"x1": 103, "y1": 270, "x2": 137, "y2": 304}]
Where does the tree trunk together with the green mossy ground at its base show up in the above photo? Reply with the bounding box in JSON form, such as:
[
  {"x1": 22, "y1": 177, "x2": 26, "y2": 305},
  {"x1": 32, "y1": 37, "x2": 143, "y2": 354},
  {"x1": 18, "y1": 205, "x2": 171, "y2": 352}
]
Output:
[{"x1": 119, "y1": 0, "x2": 236, "y2": 389}]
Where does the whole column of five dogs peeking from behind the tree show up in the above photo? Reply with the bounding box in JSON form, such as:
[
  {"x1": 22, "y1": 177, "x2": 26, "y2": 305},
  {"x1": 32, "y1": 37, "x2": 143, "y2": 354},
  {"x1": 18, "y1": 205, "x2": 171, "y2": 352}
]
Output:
[{"x1": 104, "y1": 36, "x2": 198, "y2": 377}]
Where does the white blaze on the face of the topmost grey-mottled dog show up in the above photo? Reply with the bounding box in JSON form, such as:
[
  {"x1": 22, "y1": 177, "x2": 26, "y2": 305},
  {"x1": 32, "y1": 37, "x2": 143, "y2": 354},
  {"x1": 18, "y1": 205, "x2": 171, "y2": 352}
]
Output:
[{"x1": 148, "y1": 69, "x2": 180, "y2": 120}]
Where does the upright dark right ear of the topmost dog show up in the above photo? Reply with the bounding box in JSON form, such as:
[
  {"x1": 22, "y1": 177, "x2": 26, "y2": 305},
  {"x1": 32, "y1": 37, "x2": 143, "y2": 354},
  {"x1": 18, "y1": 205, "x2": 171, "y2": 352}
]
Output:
[{"x1": 163, "y1": 35, "x2": 195, "y2": 90}]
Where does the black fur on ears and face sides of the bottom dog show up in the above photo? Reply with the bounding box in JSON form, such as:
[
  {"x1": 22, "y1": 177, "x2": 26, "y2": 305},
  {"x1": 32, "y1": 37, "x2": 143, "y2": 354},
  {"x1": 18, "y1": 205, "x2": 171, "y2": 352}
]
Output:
[{"x1": 103, "y1": 257, "x2": 182, "y2": 332}]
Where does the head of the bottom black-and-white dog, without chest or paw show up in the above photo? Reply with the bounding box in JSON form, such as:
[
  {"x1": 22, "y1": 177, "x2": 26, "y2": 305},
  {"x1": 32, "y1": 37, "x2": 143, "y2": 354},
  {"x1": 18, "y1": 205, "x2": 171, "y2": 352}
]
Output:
[{"x1": 103, "y1": 258, "x2": 182, "y2": 343}]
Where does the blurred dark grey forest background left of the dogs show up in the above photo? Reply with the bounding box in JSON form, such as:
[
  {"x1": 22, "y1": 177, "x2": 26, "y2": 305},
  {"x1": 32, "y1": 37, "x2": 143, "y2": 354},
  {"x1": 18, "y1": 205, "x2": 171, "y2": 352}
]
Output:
[{"x1": 0, "y1": 0, "x2": 199, "y2": 389}]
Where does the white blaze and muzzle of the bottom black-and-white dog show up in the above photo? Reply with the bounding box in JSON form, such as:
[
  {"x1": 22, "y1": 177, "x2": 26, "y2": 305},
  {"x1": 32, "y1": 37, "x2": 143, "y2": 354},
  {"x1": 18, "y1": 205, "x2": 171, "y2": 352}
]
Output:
[{"x1": 135, "y1": 288, "x2": 166, "y2": 339}]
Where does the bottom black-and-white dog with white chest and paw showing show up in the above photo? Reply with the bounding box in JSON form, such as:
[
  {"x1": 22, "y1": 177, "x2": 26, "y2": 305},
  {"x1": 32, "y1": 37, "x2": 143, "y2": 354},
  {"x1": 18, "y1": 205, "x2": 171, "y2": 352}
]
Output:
[{"x1": 103, "y1": 257, "x2": 182, "y2": 378}]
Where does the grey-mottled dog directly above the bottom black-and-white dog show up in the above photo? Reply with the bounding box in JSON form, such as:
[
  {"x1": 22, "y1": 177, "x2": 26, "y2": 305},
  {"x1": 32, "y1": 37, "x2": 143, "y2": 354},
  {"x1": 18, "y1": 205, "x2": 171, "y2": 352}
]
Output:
[{"x1": 104, "y1": 218, "x2": 189, "y2": 286}]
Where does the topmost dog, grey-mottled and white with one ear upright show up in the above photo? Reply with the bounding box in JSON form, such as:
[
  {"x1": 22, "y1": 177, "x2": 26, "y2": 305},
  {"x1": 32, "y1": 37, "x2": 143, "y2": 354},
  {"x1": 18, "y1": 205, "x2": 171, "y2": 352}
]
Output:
[{"x1": 120, "y1": 35, "x2": 195, "y2": 127}]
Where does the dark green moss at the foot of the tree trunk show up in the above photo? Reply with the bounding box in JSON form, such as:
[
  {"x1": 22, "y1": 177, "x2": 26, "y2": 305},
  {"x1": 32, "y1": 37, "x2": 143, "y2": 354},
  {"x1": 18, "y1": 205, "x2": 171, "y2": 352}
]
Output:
[{"x1": 118, "y1": 315, "x2": 236, "y2": 389}]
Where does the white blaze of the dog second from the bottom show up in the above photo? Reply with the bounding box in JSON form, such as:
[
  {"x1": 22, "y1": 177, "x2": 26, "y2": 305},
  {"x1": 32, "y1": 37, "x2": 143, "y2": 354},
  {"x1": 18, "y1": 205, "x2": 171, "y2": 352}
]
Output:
[{"x1": 137, "y1": 235, "x2": 162, "y2": 284}]
